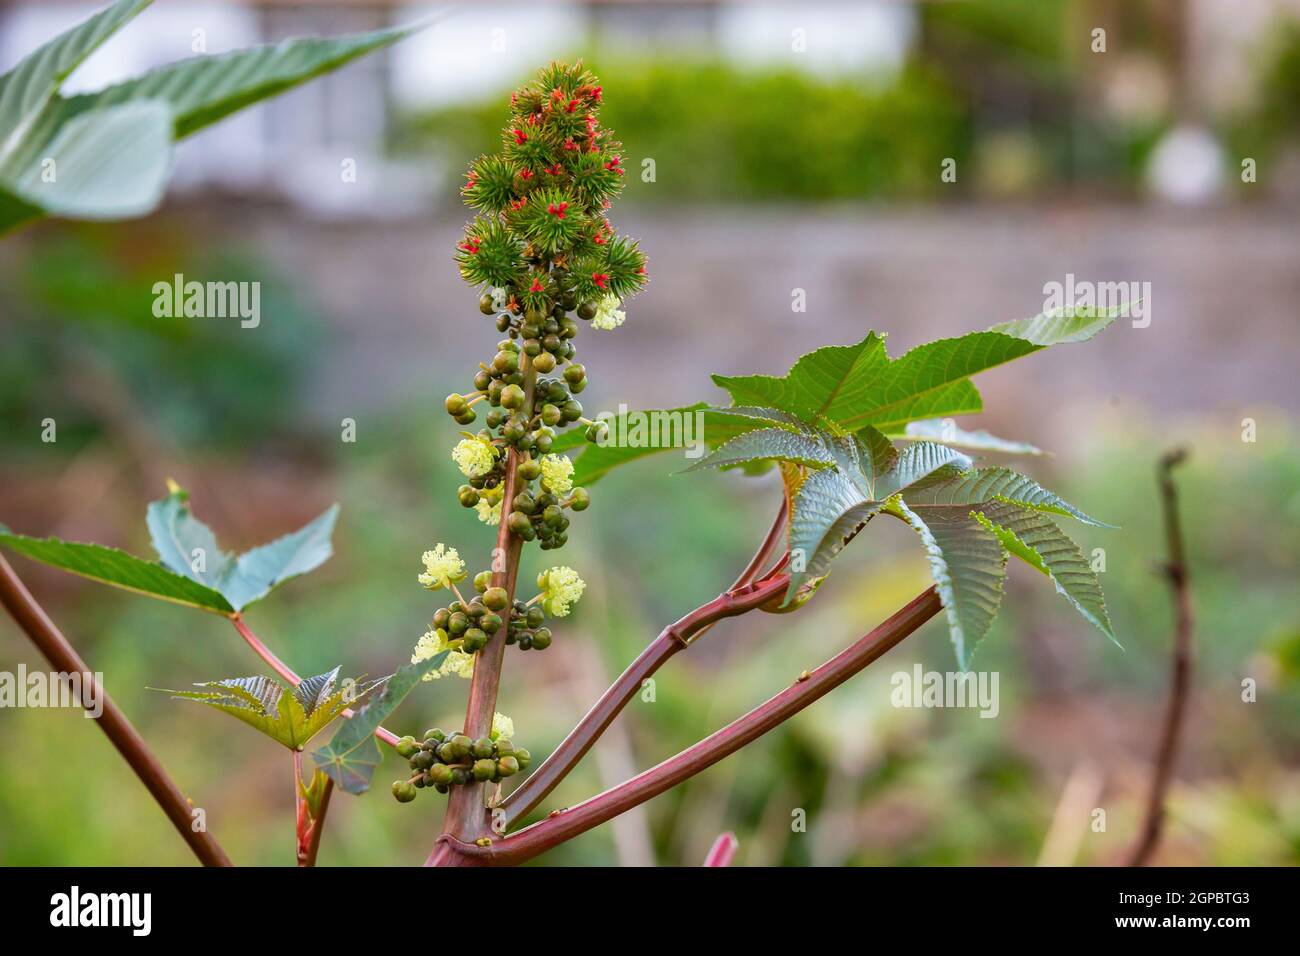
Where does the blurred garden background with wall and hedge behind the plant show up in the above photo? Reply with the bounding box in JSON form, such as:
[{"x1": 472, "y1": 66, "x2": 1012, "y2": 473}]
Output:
[{"x1": 0, "y1": 0, "x2": 1300, "y2": 865}]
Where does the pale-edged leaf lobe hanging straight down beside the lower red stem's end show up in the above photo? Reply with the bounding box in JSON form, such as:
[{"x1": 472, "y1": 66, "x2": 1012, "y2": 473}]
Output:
[{"x1": 891, "y1": 498, "x2": 1006, "y2": 670}]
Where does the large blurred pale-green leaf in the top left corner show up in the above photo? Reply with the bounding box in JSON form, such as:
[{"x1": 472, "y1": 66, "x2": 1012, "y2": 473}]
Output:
[{"x1": 0, "y1": 0, "x2": 411, "y2": 233}]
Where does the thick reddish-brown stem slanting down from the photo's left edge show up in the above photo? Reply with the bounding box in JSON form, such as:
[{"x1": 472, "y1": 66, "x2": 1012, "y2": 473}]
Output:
[{"x1": 0, "y1": 557, "x2": 230, "y2": 866}]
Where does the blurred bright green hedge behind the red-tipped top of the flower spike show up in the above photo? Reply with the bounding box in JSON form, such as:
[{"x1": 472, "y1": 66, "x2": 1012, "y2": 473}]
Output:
[{"x1": 397, "y1": 59, "x2": 969, "y2": 200}]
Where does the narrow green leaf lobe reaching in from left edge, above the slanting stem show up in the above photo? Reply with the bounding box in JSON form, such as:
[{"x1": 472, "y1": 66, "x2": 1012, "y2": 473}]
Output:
[{"x1": 0, "y1": 527, "x2": 234, "y2": 614}]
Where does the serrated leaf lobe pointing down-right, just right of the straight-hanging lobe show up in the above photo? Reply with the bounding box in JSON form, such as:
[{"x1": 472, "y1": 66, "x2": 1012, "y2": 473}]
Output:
[{"x1": 974, "y1": 502, "x2": 1119, "y2": 646}]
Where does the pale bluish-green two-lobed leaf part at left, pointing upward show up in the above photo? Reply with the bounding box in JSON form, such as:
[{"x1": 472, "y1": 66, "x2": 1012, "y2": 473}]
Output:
[{"x1": 146, "y1": 490, "x2": 338, "y2": 611}]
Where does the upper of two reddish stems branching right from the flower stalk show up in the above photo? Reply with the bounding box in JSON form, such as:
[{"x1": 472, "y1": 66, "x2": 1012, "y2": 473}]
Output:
[{"x1": 501, "y1": 575, "x2": 789, "y2": 825}]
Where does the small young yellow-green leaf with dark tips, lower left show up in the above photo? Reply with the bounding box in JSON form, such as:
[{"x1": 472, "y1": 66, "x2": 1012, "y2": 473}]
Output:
[{"x1": 155, "y1": 667, "x2": 382, "y2": 750}]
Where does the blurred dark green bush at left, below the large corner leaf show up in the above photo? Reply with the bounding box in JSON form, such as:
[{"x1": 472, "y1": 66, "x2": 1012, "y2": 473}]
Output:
[{"x1": 0, "y1": 224, "x2": 320, "y2": 458}]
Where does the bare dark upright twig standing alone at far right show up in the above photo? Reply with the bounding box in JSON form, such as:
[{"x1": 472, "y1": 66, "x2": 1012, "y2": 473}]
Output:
[{"x1": 1128, "y1": 449, "x2": 1192, "y2": 866}]
